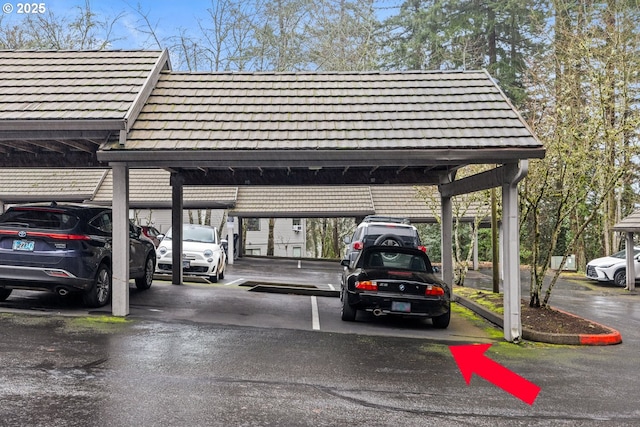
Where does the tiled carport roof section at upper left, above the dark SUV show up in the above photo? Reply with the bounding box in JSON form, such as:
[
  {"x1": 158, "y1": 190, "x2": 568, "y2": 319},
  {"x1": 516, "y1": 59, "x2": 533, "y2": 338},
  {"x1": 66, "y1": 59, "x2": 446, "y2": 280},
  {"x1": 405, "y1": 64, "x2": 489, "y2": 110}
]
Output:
[{"x1": 0, "y1": 51, "x2": 169, "y2": 167}]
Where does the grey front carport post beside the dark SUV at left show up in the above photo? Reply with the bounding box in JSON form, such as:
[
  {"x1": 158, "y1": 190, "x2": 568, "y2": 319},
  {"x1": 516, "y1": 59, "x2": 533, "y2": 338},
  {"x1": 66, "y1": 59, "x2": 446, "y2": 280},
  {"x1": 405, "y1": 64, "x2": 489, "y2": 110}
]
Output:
[{"x1": 111, "y1": 163, "x2": 129, "y2": 317}]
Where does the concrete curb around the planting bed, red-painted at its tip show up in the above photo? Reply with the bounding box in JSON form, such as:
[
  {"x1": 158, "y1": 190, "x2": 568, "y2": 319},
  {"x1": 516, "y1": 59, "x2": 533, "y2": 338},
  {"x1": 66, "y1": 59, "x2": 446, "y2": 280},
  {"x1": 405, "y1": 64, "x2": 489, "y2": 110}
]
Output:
[{"x1": 453, "y1": 294, "x2": 622, "y2": 345}]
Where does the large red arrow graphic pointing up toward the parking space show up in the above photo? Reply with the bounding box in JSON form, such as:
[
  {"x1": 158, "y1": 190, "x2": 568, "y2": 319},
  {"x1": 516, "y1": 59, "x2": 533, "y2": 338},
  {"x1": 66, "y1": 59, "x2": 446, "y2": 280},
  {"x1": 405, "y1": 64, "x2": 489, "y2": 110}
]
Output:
[{"x1": 449, "y1": 344, "x2": 540, "y2": 405}]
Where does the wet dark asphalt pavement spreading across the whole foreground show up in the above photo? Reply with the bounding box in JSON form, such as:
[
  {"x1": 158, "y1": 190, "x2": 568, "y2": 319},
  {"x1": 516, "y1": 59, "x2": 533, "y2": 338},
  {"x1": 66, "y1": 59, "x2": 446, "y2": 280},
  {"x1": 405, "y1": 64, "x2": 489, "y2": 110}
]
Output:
[{"x1": 0, "y1": 263, "x2": 640, "y2": 426}]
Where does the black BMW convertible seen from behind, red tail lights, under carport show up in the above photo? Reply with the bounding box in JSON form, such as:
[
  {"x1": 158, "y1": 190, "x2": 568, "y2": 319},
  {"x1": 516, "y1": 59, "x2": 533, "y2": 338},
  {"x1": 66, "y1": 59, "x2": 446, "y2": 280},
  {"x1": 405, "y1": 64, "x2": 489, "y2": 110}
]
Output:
[{"x1": 340, "y1": 246, "x2": 451, "y2": 329}]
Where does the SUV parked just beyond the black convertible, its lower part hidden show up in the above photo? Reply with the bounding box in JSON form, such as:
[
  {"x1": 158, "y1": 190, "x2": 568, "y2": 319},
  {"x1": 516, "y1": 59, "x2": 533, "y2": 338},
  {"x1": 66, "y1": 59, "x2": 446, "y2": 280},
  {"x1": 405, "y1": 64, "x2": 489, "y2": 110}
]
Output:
[{"x1": 344, "y1": 215, "x2": 426, "y2": 262}]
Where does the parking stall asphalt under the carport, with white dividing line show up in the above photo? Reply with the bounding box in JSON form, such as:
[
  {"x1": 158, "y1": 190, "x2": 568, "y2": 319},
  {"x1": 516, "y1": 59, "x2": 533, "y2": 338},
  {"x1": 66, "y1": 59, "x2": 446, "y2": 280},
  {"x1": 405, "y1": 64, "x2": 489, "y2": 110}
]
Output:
[{"x1": 0, "y1": 258, "x2": 490, "y2": 342}]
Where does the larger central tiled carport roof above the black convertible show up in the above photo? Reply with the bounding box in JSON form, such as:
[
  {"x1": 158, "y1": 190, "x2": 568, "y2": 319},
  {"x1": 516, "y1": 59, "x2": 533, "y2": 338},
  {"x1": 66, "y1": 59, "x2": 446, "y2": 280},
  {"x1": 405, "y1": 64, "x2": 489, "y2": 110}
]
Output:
[{"x1": 98, "y1": 71, "x2": 544, "y2": 185}]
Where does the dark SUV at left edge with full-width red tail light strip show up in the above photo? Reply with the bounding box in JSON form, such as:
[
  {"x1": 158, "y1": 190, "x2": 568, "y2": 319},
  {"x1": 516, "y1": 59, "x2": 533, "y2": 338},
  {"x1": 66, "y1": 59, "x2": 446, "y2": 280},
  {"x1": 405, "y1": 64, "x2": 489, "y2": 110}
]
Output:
[{"x1": 0, "y1": 202, "x2": 156, "y2": 307}]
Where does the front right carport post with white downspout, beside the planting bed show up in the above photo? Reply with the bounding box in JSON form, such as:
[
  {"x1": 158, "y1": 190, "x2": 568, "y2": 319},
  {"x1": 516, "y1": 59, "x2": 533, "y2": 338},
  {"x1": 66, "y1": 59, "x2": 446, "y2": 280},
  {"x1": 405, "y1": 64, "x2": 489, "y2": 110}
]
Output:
[{"x1": 501, "y1": 162, "x2": 527, "y2": 342}]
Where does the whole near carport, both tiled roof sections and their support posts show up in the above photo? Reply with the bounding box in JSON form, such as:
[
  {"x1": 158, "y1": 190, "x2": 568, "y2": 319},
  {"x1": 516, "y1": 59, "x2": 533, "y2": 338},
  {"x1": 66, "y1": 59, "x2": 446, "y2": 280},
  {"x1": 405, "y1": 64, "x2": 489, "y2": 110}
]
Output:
[{"x1": 0, "y1": 52, "x2": 544, "y2": 341}]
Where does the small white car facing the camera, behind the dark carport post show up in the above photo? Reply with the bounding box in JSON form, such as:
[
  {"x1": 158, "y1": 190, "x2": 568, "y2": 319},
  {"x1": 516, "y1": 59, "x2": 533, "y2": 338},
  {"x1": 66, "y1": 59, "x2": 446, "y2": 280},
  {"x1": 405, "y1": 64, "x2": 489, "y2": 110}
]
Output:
[{"x1": 156, "y1": 224, "x2": 227, "y2": 283}]
